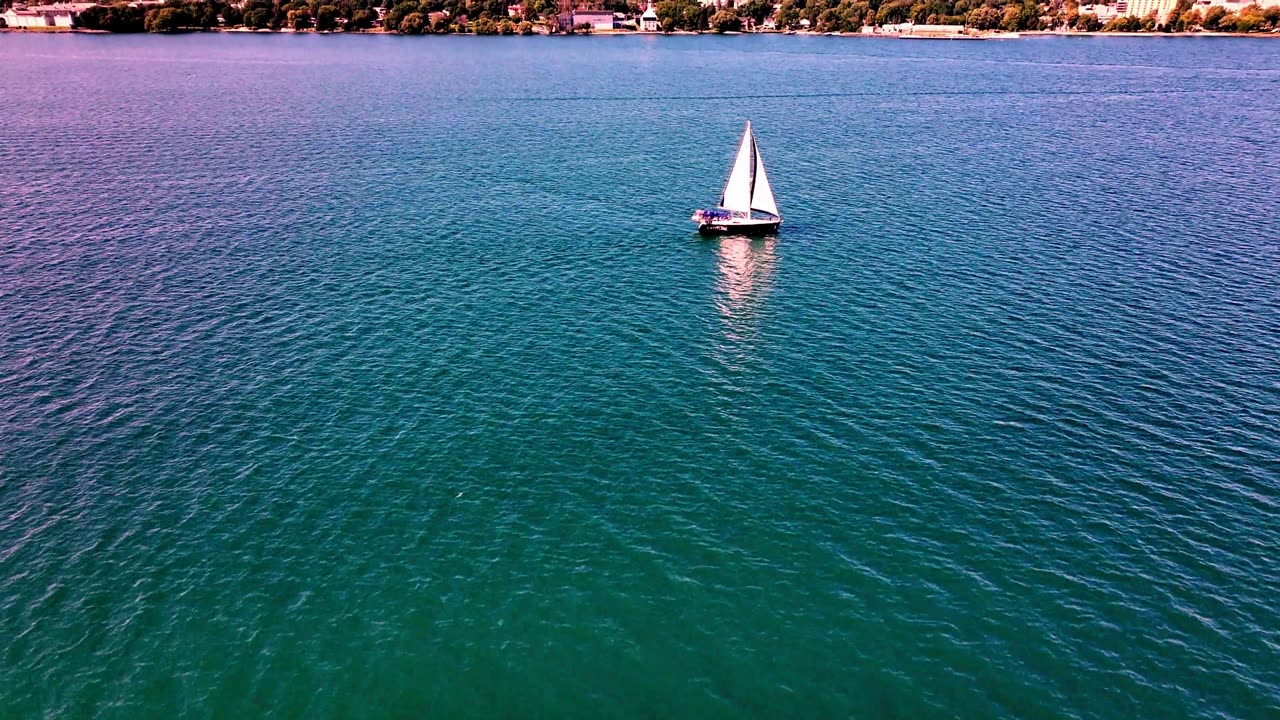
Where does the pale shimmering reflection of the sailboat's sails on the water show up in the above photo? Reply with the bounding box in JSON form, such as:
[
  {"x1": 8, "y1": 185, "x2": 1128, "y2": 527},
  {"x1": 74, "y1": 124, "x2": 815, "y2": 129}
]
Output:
[{"x1": 716, "y1": 236, "x2": 778, "y2": 368}]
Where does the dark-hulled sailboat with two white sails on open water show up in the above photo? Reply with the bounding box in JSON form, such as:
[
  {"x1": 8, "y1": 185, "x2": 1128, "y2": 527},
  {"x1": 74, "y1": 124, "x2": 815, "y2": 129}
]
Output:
[{"x1": 690, "y1": 120, "x2": 782, "y2": 234}]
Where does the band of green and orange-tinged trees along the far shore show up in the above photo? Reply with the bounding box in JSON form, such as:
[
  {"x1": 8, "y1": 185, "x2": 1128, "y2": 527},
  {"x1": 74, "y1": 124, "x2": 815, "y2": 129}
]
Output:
[{"x1": 0, "y1": 0, "x2": 1280, "y2": 35}]
